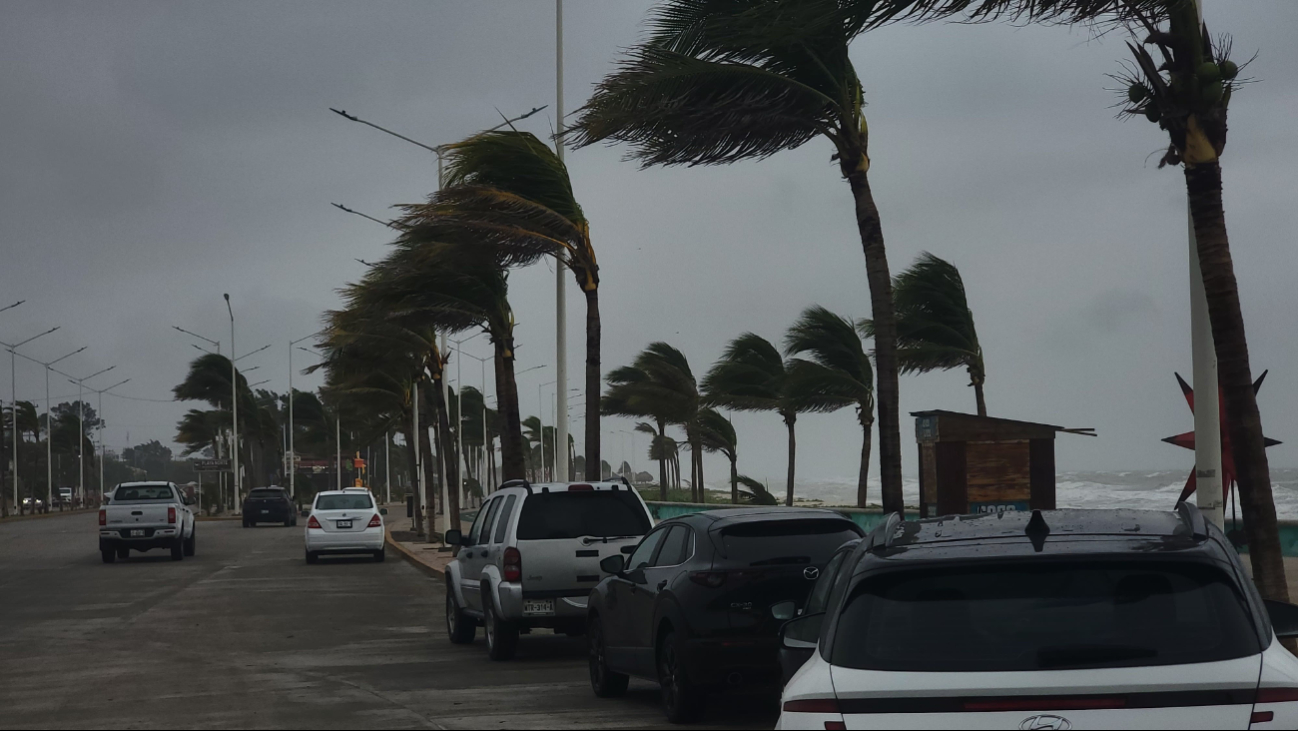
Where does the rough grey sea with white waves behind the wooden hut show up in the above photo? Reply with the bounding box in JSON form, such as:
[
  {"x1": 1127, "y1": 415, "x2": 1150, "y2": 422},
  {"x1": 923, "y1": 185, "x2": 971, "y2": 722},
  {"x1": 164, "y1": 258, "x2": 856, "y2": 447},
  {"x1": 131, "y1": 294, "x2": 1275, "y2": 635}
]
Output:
[{"x1": 747, "y1": 467, "x2": 1298, "y2": 521}]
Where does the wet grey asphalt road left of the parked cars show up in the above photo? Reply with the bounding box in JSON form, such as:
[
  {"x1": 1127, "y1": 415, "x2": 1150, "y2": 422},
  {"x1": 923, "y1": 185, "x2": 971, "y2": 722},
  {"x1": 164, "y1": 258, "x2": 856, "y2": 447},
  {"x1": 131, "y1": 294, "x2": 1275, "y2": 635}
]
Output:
[{"x1": 0, "y1": 514, "x2": 776, "y2": 728}]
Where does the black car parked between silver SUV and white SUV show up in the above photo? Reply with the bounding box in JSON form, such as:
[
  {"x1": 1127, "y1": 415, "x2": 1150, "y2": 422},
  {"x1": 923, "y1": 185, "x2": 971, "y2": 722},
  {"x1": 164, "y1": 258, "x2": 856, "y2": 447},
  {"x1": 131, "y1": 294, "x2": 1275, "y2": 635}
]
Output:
[{"x1": 587, "y1": 508, "x2": 862, "y2": 723}]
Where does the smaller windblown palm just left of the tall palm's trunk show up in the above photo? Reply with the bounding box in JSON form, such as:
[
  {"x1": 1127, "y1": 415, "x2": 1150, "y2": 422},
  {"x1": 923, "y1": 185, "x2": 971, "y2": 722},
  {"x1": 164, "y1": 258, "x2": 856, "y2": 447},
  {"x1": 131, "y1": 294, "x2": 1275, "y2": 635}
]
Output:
[{"x1": 784, "y1": 305, "x2": 877, "y2": 508}]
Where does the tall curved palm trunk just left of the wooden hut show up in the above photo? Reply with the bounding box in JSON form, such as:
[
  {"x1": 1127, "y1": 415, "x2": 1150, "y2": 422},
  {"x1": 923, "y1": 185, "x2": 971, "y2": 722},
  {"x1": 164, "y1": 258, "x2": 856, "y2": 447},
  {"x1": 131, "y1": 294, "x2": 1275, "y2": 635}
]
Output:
[{"x1": 841, "y1": 157, "x2": 905, "y2": 513}]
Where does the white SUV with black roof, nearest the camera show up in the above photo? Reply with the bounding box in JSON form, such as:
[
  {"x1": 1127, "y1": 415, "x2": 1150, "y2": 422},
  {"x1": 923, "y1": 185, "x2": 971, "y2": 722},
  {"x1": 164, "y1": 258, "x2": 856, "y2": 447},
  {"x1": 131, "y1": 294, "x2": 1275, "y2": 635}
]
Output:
[{"x1": 778, "y1": 504, "x2": 1298, "y2": 730}]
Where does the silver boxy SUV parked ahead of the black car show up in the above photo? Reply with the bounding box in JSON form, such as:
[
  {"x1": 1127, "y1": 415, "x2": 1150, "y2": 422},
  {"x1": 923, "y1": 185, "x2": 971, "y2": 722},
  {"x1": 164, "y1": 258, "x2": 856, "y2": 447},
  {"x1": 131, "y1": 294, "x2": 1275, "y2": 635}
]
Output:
[{"x1": 447, "y1": 480, "x2": 653, "y2": 660}]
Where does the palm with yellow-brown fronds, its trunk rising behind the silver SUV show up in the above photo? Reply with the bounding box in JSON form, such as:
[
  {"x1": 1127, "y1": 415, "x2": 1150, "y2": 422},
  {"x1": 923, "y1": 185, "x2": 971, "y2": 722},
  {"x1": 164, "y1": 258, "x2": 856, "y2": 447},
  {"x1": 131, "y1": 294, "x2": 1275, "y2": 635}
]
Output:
[{"x1": 402, "y1": 130, "x2": 601, "y2": 479}]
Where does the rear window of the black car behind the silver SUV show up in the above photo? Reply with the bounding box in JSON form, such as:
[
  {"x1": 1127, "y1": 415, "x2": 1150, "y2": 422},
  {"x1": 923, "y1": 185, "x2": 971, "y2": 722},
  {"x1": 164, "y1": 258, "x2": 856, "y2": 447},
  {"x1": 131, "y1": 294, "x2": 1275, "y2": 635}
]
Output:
[{"x1": 722, "y1": 518, "x2": 861, "y2": 566}]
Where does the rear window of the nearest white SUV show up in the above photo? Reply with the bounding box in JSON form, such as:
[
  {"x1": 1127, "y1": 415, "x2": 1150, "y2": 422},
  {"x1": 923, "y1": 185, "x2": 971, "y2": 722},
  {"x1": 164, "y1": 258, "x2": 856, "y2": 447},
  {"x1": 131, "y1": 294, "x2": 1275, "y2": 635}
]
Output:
[{"x1": 832, "y1": 561, "x2": 1260, "y2": 671}]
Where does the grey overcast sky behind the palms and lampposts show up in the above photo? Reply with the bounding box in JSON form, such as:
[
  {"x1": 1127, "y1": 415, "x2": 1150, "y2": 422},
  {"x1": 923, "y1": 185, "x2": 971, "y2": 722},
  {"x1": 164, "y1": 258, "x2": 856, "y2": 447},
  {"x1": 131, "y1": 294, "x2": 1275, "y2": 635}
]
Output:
[{"x1": 0, "y1": 0, "x2": 1298, "y2": 496}]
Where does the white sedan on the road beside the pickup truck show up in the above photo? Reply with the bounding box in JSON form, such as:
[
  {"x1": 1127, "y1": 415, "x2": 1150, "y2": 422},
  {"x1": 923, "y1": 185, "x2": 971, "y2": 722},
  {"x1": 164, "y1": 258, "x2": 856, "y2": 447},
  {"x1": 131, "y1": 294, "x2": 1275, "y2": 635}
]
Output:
[{"x1": 306, "y1": 487, "x2": 388, "y2": 564}]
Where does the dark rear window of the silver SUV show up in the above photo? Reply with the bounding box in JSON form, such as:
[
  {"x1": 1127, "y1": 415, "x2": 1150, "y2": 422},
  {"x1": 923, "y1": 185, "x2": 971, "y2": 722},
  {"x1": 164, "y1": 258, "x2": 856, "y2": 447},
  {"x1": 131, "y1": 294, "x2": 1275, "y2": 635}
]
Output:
[{"x1": 518, "y1": 489, "x2": 650, "y2": 540}]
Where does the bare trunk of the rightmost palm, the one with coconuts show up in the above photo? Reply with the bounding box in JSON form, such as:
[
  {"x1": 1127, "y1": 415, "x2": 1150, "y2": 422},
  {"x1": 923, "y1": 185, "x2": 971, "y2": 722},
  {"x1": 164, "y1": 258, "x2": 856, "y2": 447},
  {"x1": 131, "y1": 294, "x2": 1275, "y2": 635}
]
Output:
[{"x1": 1185, "y1": 161, "x2": 1289, "y2": 601}]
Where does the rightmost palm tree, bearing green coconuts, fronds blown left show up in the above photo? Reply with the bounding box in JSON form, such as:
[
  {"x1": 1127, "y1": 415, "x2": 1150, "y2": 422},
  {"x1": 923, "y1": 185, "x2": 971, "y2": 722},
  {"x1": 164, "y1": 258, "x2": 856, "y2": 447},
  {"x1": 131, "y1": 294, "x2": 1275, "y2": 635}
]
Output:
[{"x1": 875, "y1": 0, "x2": 1289, "y2": 601}]
